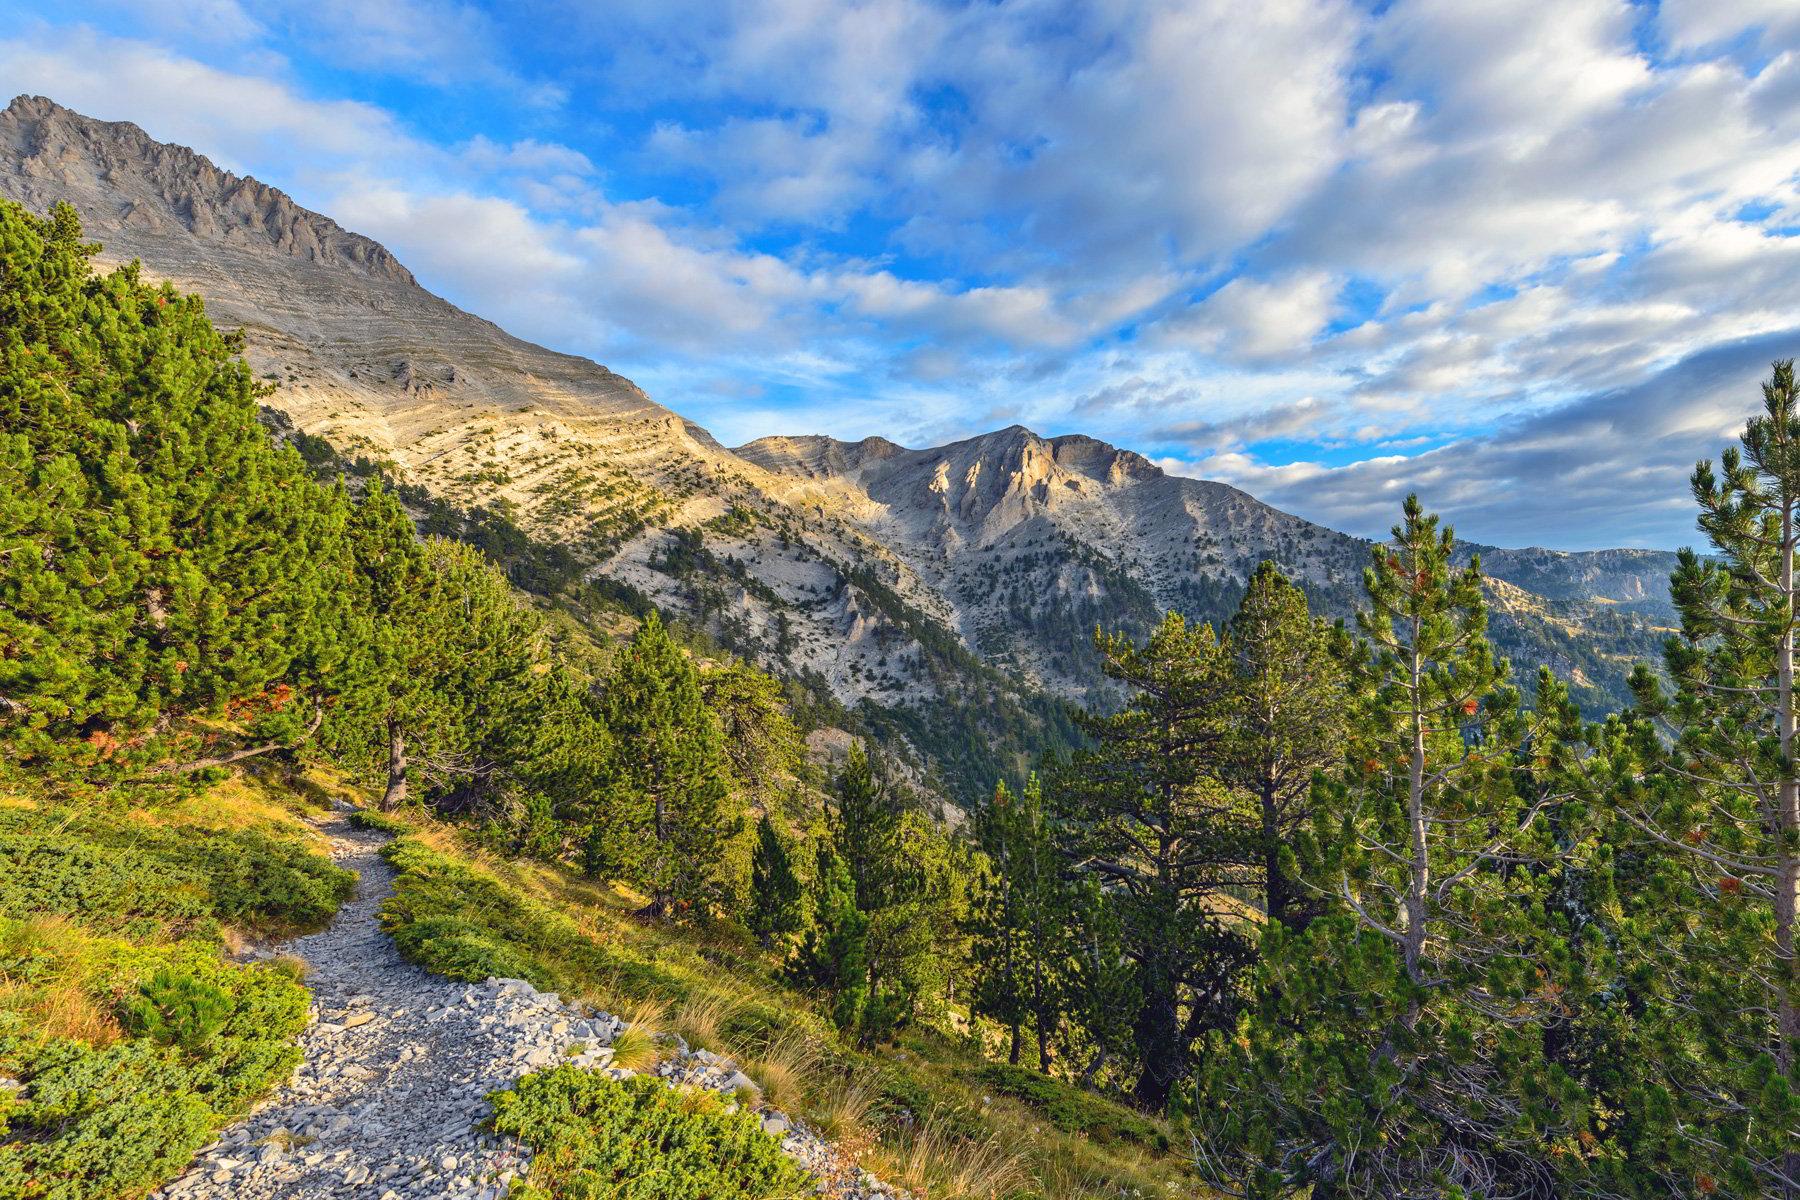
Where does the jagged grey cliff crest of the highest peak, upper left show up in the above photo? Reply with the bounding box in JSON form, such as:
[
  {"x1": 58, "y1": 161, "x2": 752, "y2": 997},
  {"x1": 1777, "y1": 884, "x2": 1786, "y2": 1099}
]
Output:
[{"x1": 0, "y1": 95, "x2": 412, "y2": 284}]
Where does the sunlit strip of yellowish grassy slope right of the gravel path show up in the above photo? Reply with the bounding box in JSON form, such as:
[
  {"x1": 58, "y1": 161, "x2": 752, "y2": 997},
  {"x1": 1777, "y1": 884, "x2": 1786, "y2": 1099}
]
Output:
[{"x1": 363, "y1": 805, "x2": 1202, "y2": 1200}]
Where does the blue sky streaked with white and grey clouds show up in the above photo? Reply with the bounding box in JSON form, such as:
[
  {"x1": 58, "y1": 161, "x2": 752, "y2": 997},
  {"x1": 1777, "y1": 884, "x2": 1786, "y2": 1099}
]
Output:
[{"x1": 0, "y1": 0, "x2": 1800, "y2": 549}]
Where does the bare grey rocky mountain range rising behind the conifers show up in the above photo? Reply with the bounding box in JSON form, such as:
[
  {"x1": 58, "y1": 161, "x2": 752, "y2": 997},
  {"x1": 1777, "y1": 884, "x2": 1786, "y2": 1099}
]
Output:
[{"x1": 0, "y1": 97, "x2": 1672, "y2": 784}]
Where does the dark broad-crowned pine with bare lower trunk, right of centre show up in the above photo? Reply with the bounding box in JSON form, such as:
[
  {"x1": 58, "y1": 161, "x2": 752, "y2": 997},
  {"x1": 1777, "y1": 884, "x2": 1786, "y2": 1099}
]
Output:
[{"x1": 1055, "y1": 613, "x2": 1249, "y2": 1108}]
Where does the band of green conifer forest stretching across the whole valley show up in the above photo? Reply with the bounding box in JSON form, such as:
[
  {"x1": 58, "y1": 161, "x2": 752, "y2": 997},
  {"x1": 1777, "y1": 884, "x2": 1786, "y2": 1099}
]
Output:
[{"x1": 0, "y1": 205, "x2": 1800, "y2": 1198}]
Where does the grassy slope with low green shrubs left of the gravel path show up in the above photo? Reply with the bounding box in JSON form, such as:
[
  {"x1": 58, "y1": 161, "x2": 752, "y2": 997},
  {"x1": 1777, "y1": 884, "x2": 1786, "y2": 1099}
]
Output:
[{"x1": 0, "y1": 775, "x2": 355, "y2": 1200}]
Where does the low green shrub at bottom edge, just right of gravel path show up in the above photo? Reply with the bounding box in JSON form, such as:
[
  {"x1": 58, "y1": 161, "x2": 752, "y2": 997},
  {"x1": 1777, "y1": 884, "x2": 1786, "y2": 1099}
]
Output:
[{"x1": 488, "y1": 1067, "x2": 812, "y2": 1200}]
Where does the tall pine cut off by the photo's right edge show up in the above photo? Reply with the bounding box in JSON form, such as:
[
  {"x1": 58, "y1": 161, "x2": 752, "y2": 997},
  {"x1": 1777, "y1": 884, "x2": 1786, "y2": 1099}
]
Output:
[{"x1": 1616, "y1": 360, "x2": 1800, "y2": 1196}]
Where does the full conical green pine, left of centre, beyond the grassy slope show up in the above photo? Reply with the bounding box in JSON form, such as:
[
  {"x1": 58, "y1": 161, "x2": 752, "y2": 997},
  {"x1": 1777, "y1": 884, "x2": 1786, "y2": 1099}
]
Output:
[{"x1": 587, "y1": 612, "x2": 742, "y2": 918}]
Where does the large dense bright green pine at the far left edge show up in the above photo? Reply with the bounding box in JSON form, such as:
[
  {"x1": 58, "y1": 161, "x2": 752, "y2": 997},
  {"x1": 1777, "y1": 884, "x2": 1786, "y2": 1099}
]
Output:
[{"x1": 0, "y1": 201, "x2": 355, "y2": 786}]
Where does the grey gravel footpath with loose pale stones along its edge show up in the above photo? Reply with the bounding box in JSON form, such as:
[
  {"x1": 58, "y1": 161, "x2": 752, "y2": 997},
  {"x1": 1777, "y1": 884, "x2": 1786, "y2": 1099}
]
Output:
[{"x1": 157, "y1": 820, "x2": 907, "y2": 1200}]
